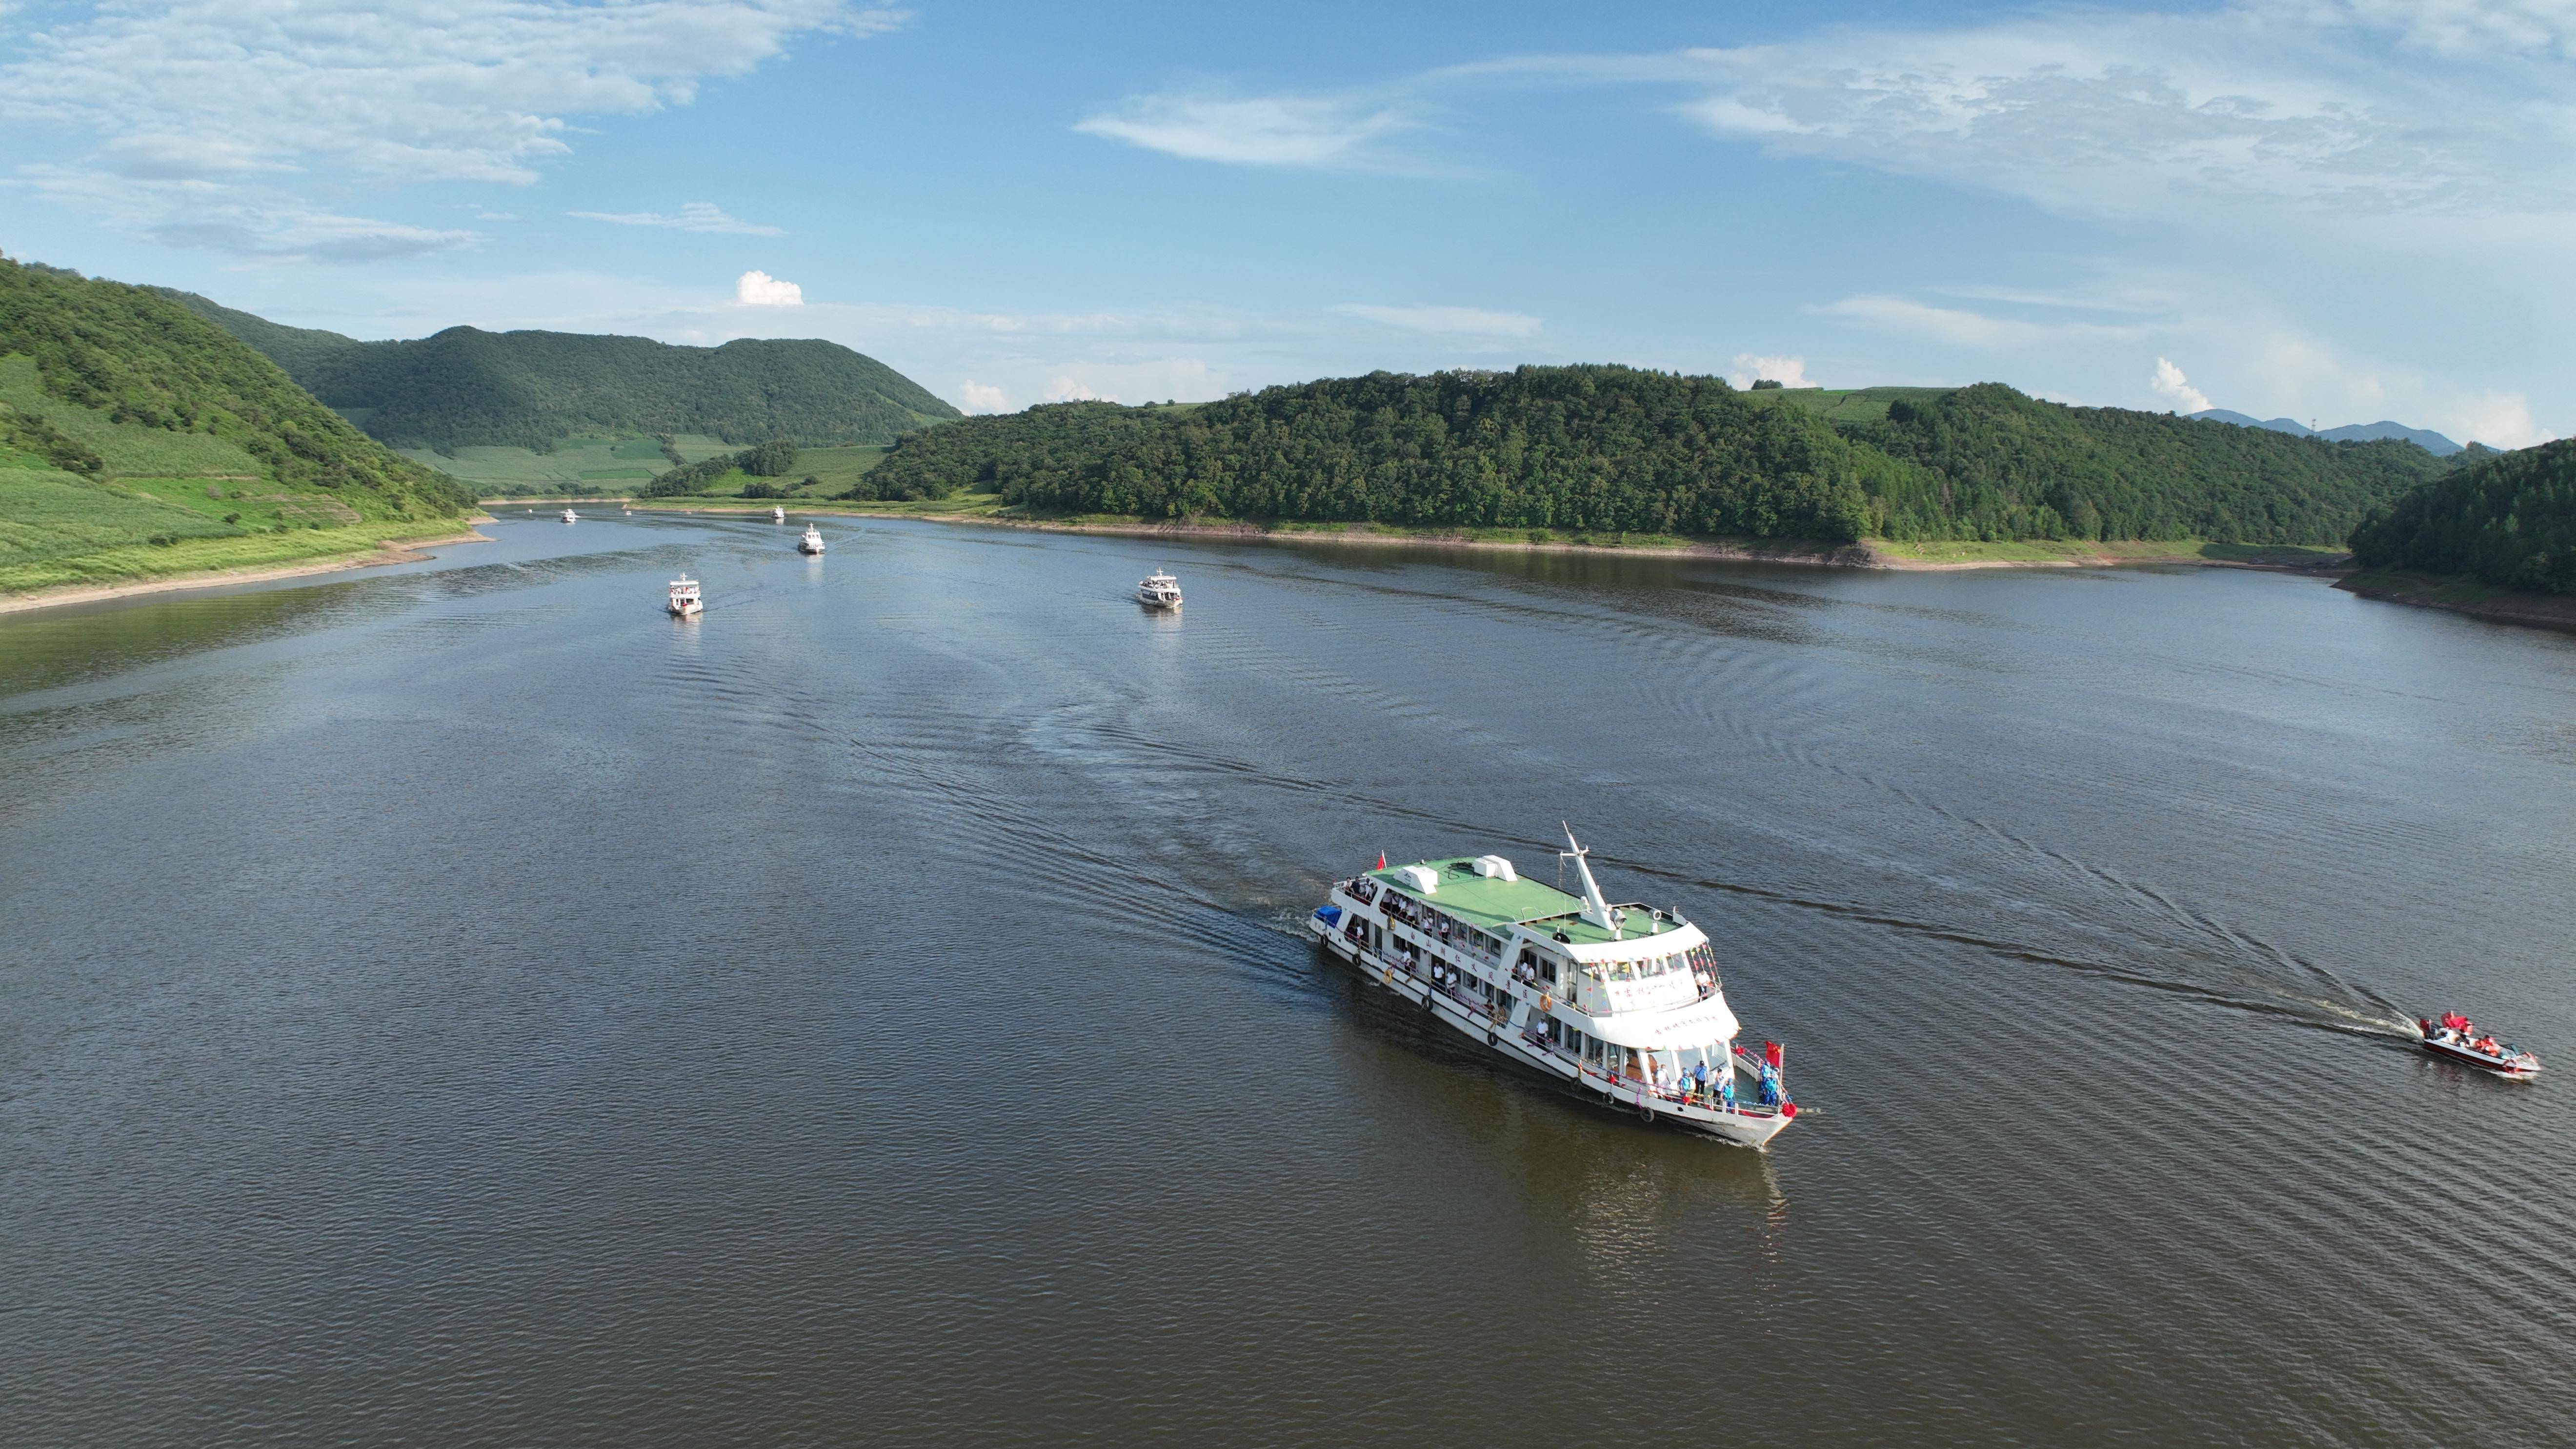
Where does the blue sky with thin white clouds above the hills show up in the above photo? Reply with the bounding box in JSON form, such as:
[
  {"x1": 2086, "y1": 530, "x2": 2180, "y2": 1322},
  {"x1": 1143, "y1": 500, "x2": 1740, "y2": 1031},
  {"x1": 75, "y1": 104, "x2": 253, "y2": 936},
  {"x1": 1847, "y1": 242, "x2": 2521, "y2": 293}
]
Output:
[{"x1": 0, "y1": 0, "x2": 2576, "y2": 446}]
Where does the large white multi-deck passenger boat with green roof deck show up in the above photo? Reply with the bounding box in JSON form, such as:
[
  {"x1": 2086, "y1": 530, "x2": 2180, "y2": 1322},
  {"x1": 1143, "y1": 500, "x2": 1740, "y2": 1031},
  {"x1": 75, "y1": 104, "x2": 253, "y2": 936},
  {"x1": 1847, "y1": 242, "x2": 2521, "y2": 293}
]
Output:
[{"x1": 1308, "y1": 830, "x2": 1798, "y2": 1147}]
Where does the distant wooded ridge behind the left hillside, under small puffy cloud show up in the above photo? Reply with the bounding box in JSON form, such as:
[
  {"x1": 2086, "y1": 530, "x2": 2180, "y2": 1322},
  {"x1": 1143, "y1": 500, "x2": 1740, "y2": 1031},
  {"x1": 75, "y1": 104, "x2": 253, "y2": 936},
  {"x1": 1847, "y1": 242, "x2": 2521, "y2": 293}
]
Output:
[{"x1": 157, "y1": 289, "x2": 958, "y2": 454}]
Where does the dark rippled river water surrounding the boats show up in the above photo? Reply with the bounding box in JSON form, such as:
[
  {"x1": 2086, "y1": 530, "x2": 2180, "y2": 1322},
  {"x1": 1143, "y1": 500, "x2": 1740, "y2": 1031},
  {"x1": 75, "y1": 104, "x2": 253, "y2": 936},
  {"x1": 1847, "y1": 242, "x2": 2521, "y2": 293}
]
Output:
[{"x1": 0, "y1": 518, "x2": 2576, "y2": 1444}]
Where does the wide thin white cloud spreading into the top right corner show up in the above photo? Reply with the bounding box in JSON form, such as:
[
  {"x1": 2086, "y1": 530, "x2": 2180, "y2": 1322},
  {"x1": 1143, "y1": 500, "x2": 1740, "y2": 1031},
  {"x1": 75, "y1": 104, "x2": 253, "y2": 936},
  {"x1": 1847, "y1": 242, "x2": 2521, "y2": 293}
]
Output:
[{"x1": 1682, "y1": 0, "x2": 2576, "y2": 219}]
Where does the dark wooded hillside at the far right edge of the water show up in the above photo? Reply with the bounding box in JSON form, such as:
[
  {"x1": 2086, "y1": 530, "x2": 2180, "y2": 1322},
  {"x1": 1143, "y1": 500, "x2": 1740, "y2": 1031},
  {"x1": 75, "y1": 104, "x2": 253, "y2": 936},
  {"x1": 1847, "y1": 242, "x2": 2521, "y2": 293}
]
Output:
[{"x1": 2352, "y1": 438, "x2": 2576, "y2": 593}]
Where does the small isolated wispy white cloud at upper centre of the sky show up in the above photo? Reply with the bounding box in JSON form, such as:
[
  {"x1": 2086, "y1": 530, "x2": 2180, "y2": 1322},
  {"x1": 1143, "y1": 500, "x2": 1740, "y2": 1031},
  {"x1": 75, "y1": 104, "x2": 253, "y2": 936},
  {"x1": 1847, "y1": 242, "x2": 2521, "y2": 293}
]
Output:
[{"x1": 1074, "y1": 96, "x2": 1419, "y2": 170}]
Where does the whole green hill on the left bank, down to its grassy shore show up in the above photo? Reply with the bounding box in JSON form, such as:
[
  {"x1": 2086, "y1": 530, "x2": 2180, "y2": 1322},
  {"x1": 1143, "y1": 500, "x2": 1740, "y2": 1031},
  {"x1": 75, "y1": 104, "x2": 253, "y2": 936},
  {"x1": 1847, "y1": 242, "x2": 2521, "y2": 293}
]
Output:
[{"x1": 0, "y1": 258, "x2": 469, "y2": 590}]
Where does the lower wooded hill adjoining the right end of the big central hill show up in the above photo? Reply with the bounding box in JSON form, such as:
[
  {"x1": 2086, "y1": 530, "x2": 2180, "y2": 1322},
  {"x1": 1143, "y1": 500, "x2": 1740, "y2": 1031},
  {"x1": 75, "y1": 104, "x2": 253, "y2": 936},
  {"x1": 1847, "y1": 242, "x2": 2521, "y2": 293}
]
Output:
[{"x1": 1844, "y1": 382, "x2": 2447, "y2": 544}]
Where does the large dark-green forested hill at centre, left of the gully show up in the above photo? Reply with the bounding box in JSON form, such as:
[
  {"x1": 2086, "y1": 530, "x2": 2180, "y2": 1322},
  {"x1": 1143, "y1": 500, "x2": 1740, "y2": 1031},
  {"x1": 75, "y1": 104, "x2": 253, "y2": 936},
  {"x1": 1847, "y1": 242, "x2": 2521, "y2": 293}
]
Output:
[{"x1": 868, "y1": 366, "x2": 1888, "y2": 539}]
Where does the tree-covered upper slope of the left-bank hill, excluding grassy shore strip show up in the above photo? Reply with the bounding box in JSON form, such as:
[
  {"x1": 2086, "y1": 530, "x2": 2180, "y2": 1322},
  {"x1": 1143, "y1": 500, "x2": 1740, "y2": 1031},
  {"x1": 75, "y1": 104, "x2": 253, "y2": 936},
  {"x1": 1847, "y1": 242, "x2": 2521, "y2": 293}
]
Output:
[{"x1": 0, "y1": 258, "x2": 471, "y2": 516}]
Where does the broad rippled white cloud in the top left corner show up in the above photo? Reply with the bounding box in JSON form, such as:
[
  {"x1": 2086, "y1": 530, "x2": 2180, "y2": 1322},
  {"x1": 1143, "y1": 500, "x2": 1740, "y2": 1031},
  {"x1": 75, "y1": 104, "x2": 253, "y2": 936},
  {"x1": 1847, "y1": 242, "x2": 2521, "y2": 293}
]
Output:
[{"x1": 0, "y1": 0, "x2": 902, "y2": 261}]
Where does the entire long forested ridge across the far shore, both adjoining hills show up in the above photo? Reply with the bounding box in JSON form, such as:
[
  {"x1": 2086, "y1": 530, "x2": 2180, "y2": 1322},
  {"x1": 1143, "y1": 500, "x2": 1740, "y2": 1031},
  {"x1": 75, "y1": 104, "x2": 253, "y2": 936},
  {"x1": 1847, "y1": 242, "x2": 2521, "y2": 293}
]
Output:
[{"x1": 861, "y1": 366, "x2": 2442, "y2": 544}]
